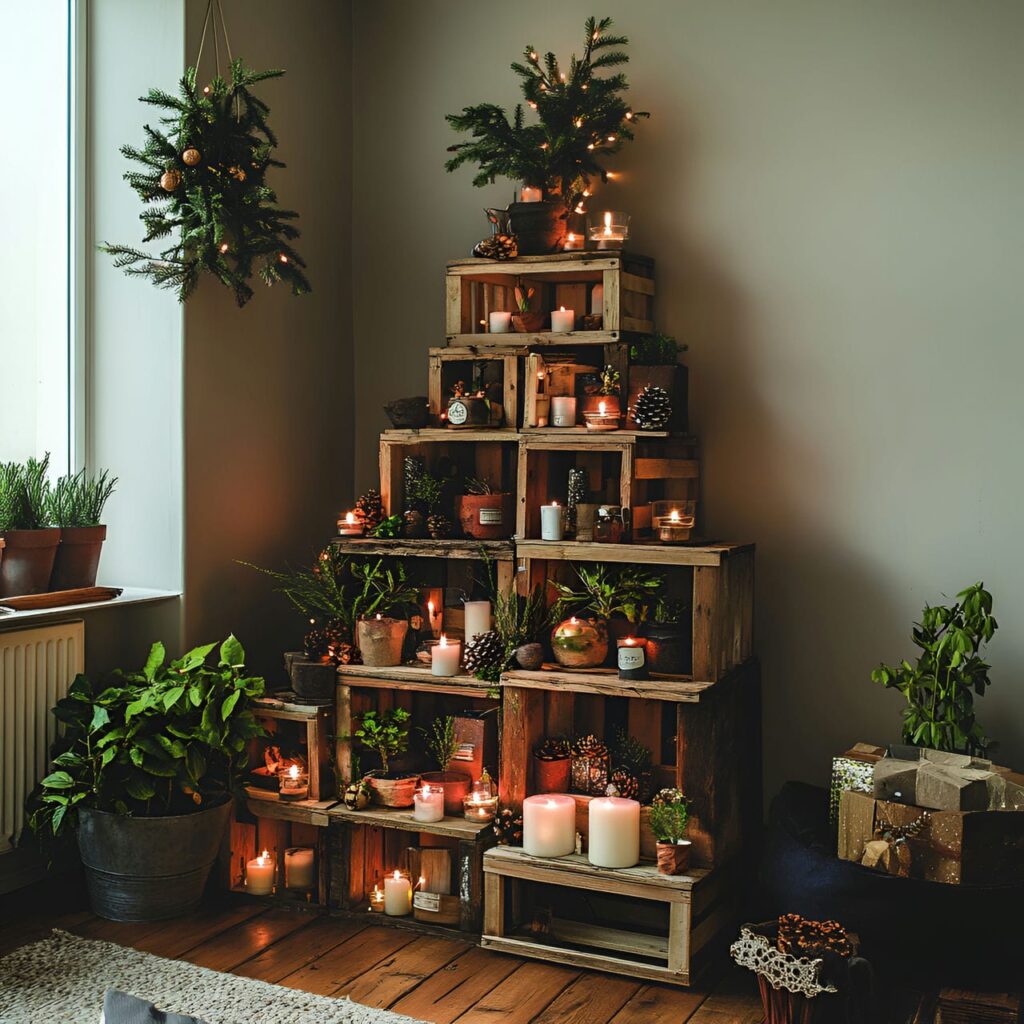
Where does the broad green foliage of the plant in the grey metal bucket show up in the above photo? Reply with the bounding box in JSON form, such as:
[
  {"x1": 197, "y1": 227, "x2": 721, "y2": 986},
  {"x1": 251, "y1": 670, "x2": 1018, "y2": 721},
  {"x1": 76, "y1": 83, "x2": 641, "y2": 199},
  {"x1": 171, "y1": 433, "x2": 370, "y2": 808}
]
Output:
[{"x1": 30, "y1": 636, "x2": 264, "y2": 836}]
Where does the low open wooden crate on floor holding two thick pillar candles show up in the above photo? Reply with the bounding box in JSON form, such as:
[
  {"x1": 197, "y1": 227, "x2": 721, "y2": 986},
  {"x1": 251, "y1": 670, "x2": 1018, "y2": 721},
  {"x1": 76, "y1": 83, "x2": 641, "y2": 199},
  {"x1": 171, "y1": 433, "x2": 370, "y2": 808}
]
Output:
[{"x1": 480, "y1": 846, "x2": 735, "y2": 985}]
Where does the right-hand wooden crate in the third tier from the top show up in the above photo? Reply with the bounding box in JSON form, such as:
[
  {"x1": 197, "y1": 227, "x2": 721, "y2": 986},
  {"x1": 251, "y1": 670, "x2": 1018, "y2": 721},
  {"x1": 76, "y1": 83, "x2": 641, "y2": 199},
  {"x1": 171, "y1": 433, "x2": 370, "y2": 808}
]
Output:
[{"x1": 516, "y1": 427, "x2": 700, "y2": 541}]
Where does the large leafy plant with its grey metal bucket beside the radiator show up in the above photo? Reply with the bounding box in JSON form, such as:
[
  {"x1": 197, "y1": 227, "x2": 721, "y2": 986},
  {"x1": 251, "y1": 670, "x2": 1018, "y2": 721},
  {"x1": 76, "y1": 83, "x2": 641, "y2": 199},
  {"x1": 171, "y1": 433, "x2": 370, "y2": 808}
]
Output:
[{"x1": 30, "y1": 637, "x2": 264, "y2": 921}]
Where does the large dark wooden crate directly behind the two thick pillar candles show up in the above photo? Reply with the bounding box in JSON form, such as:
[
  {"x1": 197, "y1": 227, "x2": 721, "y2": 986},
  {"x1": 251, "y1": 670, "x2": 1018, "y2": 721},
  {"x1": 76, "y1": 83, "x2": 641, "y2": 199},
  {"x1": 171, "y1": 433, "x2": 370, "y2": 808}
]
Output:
[{"x1": 499, "y1": 658, "x2": 761, "y2": 867}]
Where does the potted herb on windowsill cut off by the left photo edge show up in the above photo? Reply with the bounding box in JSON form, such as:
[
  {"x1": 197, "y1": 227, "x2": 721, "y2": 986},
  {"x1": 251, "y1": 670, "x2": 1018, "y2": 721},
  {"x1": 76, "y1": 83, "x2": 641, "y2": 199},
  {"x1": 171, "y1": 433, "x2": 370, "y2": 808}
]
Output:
[{"x1": 0, "y1": 453, "x2": 60, "y2": 597}]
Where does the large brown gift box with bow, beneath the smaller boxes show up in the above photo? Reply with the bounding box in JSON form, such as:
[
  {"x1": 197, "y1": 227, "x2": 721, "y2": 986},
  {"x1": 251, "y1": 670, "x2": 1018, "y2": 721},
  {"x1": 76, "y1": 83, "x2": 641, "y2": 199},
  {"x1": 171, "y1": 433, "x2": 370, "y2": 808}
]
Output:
[{"x1": 839, "y1": 791, "x2": 1024, "y2": 886}]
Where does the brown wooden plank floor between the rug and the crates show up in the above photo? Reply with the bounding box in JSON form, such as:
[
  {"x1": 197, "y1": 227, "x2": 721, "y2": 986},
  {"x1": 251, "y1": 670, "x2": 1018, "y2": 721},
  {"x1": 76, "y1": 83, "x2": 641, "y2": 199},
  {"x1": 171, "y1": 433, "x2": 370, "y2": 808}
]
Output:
[{"x1": 0, "y1": 884, "x2": 761, "y2": 1024}]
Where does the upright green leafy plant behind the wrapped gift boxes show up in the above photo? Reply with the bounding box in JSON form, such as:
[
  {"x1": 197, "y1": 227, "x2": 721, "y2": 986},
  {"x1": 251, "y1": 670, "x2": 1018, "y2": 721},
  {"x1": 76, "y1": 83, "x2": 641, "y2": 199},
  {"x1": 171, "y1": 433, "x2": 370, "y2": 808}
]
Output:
[{"x1": 871, "y1": 583, "x2": 998, "y2": 754}]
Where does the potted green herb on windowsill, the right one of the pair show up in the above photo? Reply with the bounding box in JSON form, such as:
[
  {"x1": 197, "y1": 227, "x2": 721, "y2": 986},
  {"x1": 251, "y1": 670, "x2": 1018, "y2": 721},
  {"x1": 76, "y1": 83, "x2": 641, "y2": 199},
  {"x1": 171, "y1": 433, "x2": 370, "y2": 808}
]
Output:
[{"x1": 49, "y1": 469, "x2": 118, "y2": 590}]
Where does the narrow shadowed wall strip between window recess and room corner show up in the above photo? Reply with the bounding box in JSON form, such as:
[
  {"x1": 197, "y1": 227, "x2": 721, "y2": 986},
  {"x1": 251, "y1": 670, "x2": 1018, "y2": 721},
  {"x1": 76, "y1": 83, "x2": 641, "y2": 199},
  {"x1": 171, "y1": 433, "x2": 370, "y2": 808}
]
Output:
[{"x1": 184, "y1": 0, "x2": 352, "y2": 677}]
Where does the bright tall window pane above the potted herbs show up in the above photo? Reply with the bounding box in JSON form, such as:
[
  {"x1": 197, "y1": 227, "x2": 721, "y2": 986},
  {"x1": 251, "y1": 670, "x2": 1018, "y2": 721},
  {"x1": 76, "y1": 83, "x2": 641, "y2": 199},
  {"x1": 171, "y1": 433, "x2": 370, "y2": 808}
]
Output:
[{"x1": 0, "y1": 0, "x2": 80, "y2": 472}]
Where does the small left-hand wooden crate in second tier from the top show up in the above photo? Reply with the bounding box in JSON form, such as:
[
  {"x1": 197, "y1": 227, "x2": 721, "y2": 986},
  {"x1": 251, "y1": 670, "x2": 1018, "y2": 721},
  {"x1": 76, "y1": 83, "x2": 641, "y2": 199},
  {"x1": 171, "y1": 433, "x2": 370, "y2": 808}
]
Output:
[{"x1": 427, "y1": 344, "x2": 529, "y2": 429}]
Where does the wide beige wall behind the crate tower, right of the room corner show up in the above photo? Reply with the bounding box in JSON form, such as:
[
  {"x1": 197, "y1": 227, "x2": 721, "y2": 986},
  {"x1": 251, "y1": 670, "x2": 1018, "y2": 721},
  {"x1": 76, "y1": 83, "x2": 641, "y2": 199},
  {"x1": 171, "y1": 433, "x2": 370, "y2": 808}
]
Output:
[{"x1": 353, "y1": 0, "x2": 1024, "y2": 795}]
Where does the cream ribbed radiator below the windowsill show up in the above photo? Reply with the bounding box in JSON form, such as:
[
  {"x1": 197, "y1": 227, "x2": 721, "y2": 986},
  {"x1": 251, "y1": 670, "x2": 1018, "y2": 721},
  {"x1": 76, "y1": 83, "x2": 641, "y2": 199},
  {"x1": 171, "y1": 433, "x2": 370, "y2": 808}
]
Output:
[{"x1": 0, "y1": 621, "x2": 85, "y2": 853}]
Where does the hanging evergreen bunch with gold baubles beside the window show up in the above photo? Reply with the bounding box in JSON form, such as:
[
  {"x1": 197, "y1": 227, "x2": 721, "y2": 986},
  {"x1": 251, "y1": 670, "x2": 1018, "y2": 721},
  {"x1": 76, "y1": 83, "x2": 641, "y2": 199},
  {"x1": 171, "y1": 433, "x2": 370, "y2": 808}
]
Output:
[{"x1": 101, "y1": 58, "x2": 310, "y2": 306}]
